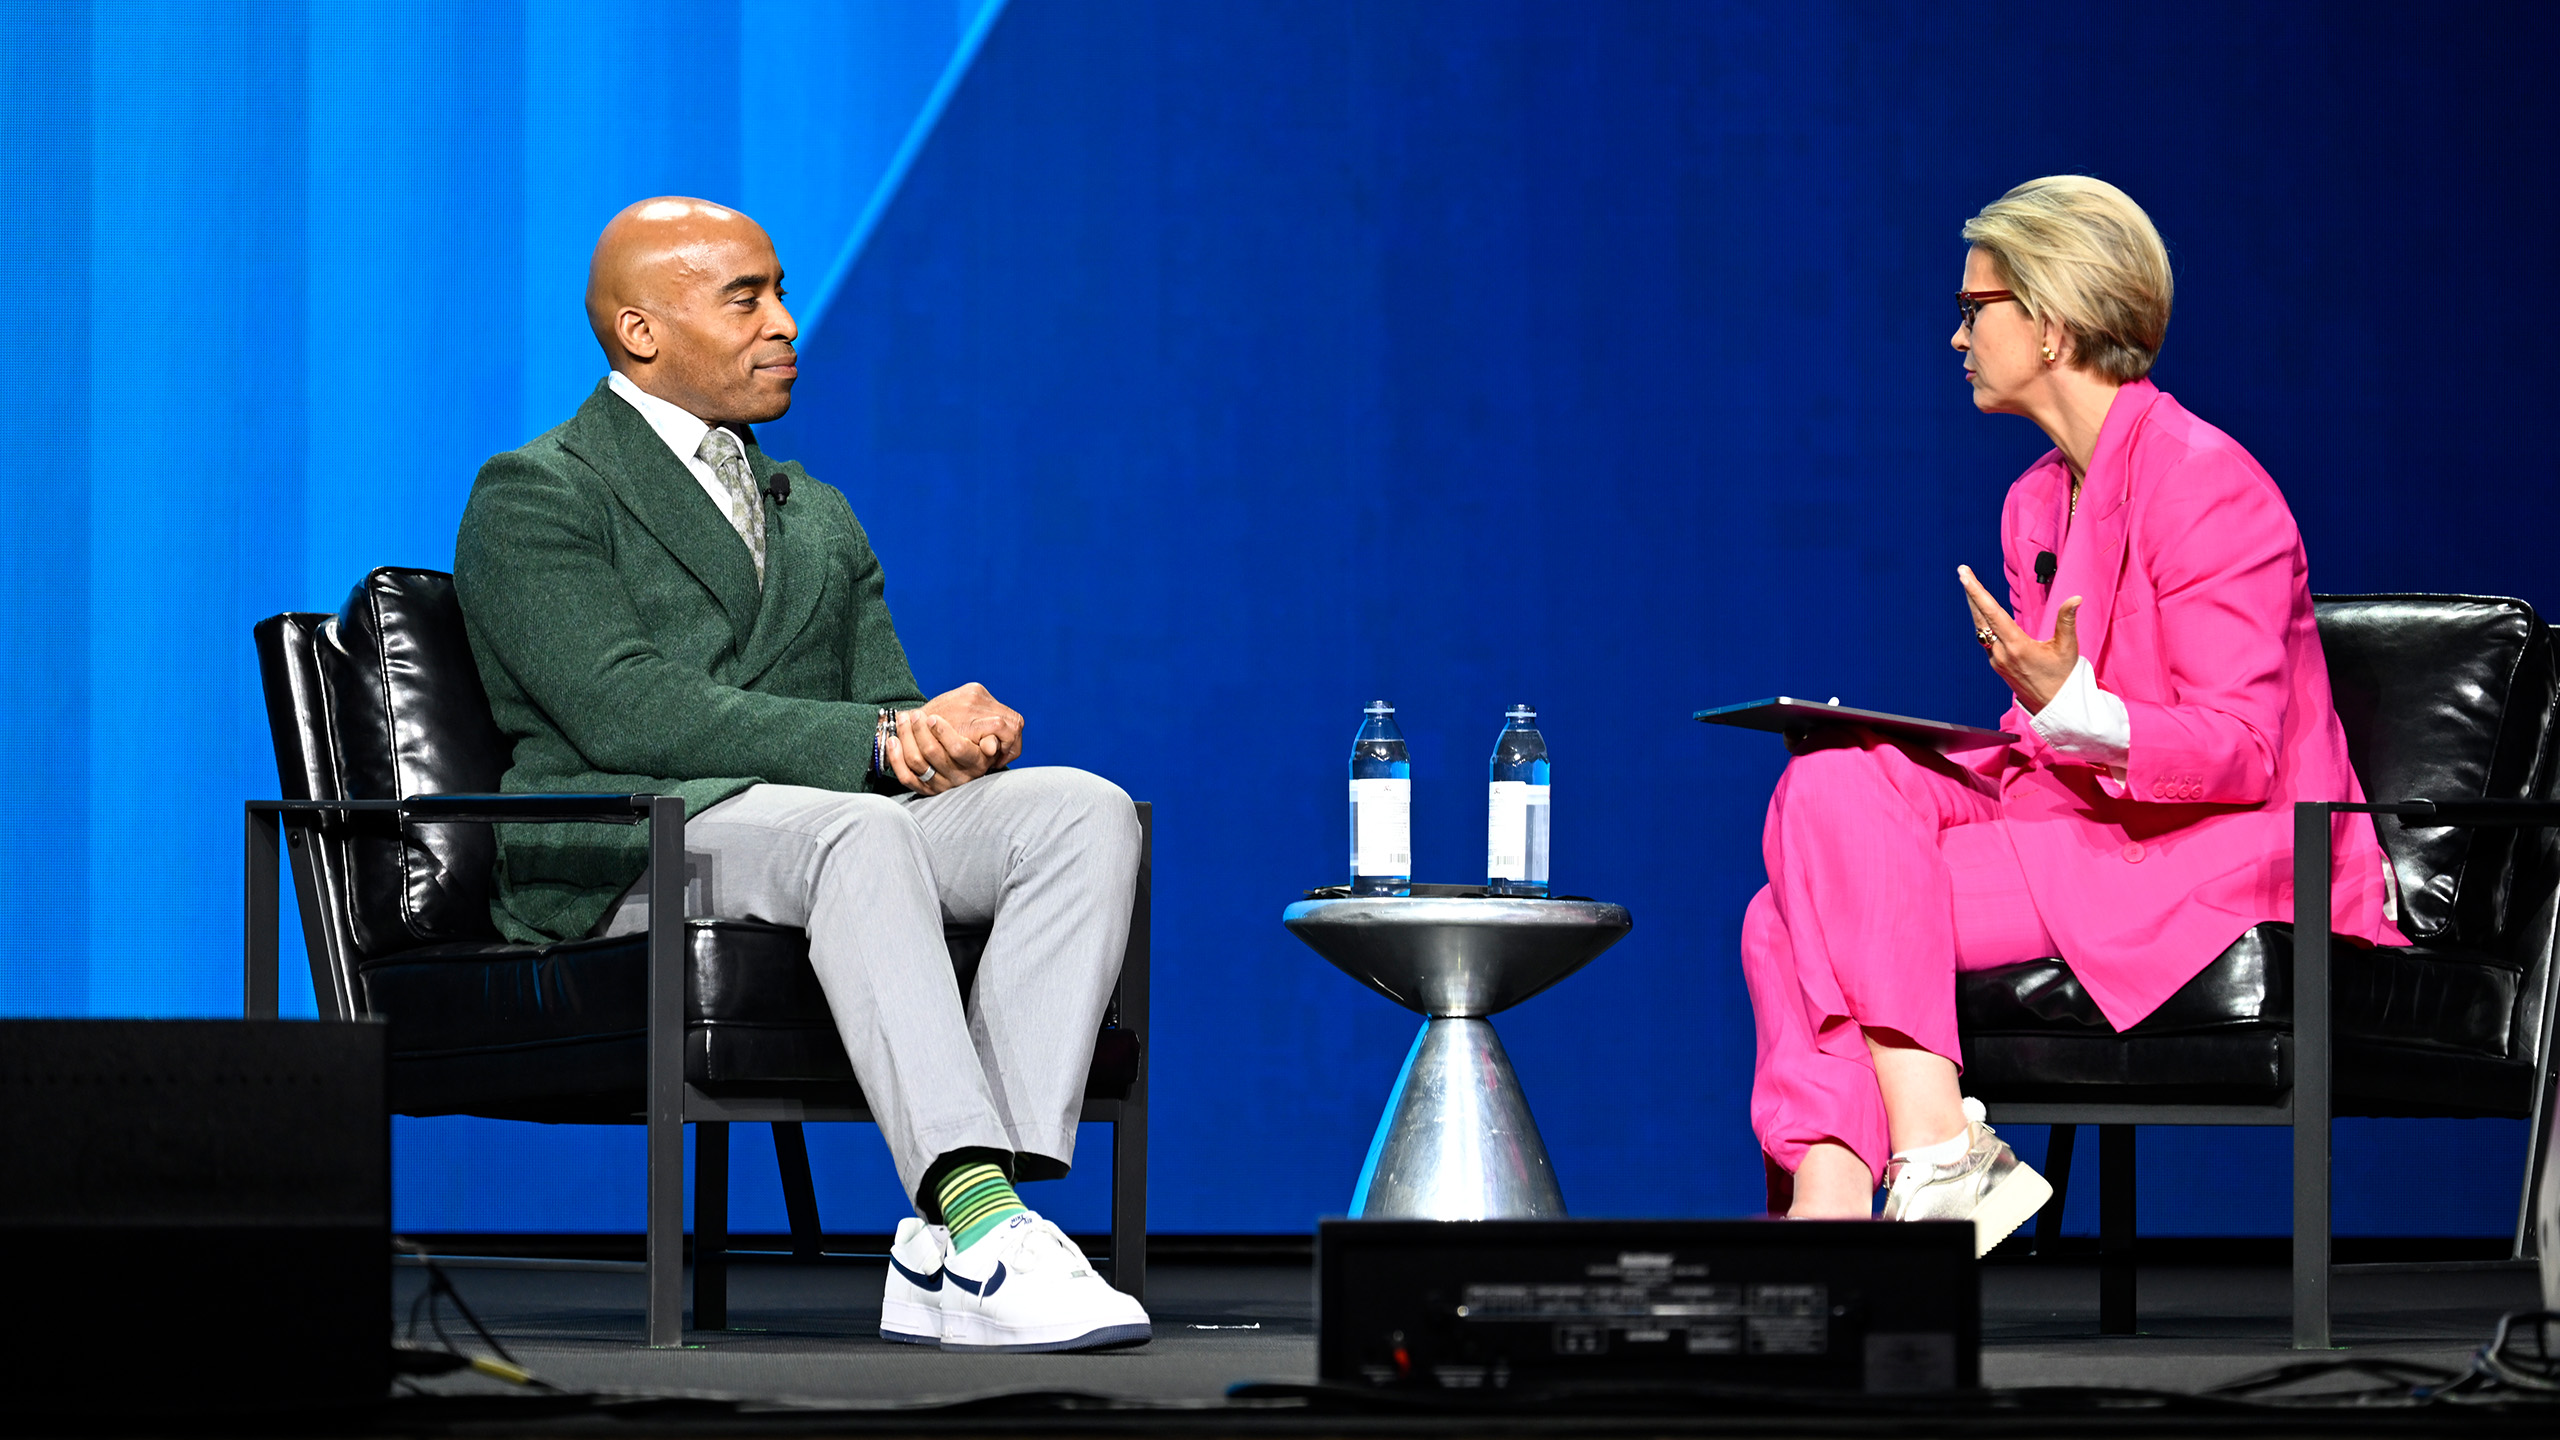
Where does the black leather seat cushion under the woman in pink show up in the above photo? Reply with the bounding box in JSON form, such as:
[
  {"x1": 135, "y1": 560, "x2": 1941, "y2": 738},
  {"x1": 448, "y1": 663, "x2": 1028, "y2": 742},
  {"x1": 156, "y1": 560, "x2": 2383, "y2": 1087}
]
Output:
[{"x1": 1956, "y1": 925, "x2": 2532, "y2": 1115}]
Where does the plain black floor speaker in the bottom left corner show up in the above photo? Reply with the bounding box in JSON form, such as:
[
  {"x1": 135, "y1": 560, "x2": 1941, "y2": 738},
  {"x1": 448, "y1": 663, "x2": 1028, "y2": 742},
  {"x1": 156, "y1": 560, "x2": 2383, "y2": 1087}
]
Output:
[{"x1": 0, "y1": 1020, "x2": 392, "y2": 1414}]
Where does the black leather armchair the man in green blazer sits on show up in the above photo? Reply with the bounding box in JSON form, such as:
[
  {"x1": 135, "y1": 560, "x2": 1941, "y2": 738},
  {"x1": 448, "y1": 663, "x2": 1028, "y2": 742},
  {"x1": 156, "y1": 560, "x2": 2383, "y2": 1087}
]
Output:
[{"x1": 246, "y1": 569, "x2": 1152, "y2": 1345}]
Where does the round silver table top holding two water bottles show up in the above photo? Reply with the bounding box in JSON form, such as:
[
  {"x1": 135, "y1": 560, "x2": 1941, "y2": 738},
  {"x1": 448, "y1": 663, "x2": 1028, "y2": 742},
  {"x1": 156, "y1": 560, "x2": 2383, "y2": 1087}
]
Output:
[{"x1": 1280, "y1": 884, "x2": 1636, "y2": 1017}]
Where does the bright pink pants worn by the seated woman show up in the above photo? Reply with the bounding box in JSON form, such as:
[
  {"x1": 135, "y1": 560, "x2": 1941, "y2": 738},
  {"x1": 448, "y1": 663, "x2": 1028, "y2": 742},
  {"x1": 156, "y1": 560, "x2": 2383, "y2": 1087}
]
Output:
[{"x1": 1743, "y1": 743, "x2": 2056, "y2": 1202}]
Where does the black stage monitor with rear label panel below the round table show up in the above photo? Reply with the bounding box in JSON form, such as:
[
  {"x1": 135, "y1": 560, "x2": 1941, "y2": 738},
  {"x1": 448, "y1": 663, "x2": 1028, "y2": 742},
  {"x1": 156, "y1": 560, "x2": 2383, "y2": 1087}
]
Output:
[{"x1": 1316, "y1": 1220, "x2": 1981, "y2": 1394}]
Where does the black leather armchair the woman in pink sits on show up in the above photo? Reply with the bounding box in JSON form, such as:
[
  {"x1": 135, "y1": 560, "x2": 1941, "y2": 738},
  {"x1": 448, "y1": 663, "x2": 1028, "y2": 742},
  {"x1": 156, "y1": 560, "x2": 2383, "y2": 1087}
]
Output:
[{"x1": 1956, "y1": 594, "x2": 2560, "y2": 1348}]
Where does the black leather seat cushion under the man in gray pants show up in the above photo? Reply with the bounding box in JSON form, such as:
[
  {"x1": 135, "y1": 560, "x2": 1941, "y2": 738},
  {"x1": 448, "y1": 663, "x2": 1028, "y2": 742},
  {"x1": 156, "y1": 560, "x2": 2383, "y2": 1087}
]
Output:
[{"x1": 358, "y1": 920, "x2": 1139, "y2": 1120}]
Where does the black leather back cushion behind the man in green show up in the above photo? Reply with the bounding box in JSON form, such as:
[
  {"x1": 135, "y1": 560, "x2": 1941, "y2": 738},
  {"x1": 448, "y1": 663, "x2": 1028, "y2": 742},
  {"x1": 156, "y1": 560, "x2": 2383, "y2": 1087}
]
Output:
[{"x1": 320, "y1": 566, "x2": 507, "y2": 956}]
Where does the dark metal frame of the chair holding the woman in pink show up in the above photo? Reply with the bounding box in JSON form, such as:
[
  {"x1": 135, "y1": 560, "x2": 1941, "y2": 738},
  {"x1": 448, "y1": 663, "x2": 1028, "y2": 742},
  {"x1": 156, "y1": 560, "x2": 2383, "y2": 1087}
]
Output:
[{"x1": 1984, "y1": 799, "x2": 2560, "y2": 1350}]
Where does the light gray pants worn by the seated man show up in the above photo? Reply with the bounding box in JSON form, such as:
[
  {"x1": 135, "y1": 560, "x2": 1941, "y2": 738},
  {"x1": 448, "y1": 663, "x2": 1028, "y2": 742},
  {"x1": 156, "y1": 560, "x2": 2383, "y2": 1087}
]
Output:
[{"x1": 599, "y1": 769, "x2": 1139, "y2": 1197}]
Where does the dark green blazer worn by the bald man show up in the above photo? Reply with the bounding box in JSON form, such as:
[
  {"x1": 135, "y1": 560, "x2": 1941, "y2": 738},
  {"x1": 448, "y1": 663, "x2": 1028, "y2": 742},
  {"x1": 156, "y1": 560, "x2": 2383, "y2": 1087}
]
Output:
[{"x1": 453, "y1": 384, "x2": 924, "y2": 943}]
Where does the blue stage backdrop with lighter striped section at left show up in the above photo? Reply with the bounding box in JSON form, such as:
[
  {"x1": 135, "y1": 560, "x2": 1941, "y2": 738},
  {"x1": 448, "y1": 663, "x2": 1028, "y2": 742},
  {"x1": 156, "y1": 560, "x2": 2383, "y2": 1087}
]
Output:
[{"x1": 0, "y1": 0, "x2": 2560, "y2": 1232}]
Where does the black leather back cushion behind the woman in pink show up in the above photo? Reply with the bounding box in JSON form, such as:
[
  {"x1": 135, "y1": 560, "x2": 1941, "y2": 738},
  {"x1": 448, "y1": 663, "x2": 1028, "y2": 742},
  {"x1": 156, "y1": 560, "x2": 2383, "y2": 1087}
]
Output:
[{"x1": 2317, "y1": 594, "x2": 2555, "y2": 945}]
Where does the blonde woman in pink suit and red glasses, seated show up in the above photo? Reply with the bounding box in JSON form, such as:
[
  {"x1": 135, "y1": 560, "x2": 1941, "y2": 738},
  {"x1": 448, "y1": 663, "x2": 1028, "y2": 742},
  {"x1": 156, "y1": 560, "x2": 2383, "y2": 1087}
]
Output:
[{"x1": 1743, "y1": 174, "x2": 2404, "y2": 1250}]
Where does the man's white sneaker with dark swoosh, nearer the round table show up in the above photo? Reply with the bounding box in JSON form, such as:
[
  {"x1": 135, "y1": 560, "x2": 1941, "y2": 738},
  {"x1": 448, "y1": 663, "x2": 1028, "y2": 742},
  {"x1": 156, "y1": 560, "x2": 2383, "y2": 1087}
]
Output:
[{"x1": 942, "y1": 1209, "x2": 1155, "y2": 1350}]
